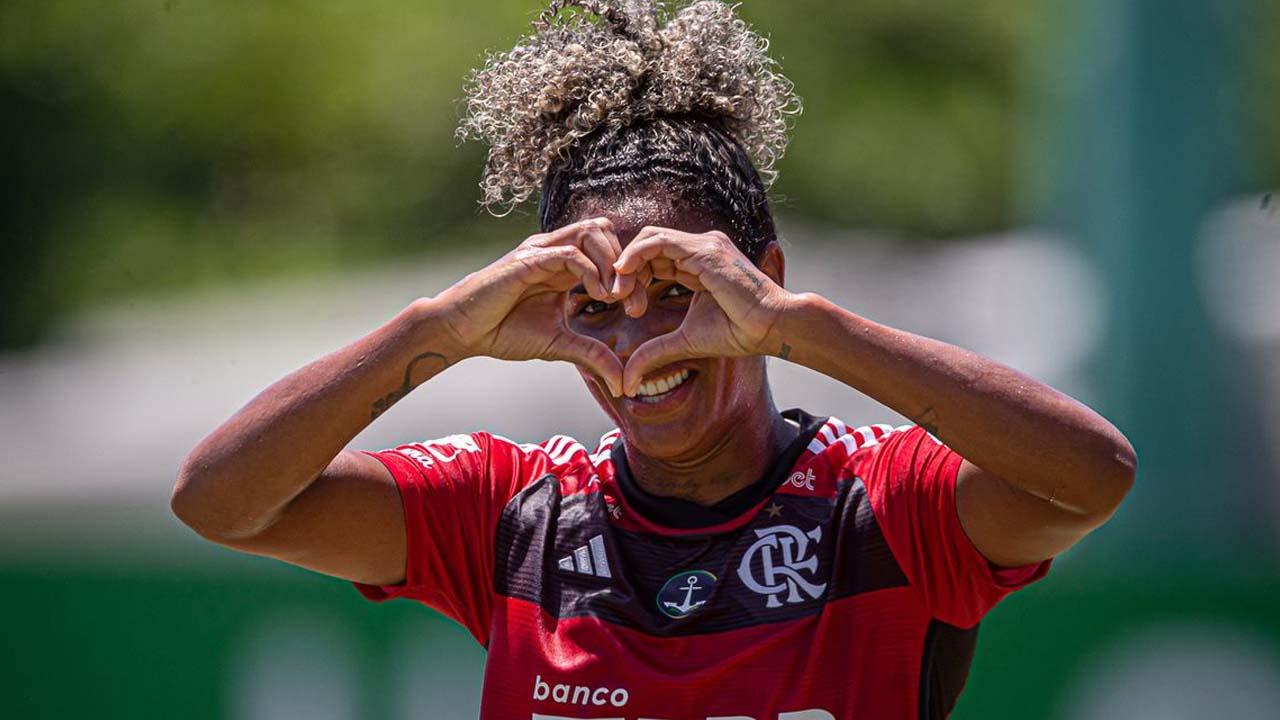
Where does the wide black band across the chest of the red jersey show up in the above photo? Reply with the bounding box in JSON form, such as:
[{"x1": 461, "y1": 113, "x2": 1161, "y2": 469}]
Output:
[{"x1": 494, "y1": 475, "x2": 908, "y2": 637}]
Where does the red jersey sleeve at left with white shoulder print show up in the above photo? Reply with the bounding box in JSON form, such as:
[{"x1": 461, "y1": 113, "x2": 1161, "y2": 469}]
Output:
[{"x1": 356, "y1": 433, "x2": 536, "y2": 646}]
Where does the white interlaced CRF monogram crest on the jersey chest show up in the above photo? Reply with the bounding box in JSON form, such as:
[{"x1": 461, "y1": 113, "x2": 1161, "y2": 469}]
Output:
[{"x1": 737, "y1": 525, "x2": 827, "y2": 607}]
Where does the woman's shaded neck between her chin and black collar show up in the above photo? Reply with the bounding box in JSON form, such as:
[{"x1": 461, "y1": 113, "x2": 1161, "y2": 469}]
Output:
[{"x1": 625, "y1": 392, "x2": 799, "y2": 505}]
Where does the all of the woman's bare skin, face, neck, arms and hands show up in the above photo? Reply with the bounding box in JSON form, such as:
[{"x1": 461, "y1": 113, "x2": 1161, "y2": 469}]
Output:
[{"x1": 172, "y1": 191, "x2": 1135, "y2": 584}]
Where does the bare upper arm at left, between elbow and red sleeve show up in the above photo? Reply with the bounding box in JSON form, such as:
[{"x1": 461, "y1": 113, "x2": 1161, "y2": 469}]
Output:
[{"x1": 221, "y1": 451, "x2": 407, "y2": 585}]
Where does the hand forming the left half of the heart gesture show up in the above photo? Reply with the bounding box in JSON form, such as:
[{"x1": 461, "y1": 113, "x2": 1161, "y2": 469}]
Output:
[{"x1": 436, "y1": 218, "x2": 622, "y2": 395}]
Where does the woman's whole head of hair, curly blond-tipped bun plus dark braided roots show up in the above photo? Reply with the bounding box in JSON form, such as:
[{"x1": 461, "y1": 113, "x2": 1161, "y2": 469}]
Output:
[{"x1": 457, "y1": 0, "x2": 800, "y2": 259}]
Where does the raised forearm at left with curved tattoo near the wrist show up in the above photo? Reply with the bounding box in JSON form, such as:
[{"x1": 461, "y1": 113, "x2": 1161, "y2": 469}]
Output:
[{"x1": 173, "y1": 294, "x2": 461, "y2": 538}]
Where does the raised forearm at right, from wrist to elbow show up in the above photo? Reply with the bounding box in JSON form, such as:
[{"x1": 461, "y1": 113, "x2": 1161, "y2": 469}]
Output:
[{"x1": 774, "y1": 295, "x2": 1135, "y2": 515}]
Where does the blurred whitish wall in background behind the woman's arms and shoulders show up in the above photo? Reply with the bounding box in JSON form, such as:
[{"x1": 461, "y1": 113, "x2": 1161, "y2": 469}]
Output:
[{"x1": 0, "y1": 224, "x2": 1107, "y2": 559}]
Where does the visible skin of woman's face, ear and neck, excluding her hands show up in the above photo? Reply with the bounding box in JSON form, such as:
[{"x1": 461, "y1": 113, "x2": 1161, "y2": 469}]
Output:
[{"x1": 564, "y1": 195, "x2": 797, "y2": 505}]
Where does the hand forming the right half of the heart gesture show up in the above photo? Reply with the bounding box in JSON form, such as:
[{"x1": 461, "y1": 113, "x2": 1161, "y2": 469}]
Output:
[{"x1": 612, "y1": 227, "x2": 794, "y2": 396}]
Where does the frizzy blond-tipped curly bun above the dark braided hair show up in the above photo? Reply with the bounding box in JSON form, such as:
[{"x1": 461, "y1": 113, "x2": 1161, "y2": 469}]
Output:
[{"x1": 457, "y1": 0, "x2": 800, "y2": 210}]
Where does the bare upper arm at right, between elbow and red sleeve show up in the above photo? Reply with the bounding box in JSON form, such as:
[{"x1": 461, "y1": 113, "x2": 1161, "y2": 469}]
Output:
[{"x1": 955, "y1": 460, "x2": 1106, "y2": 568}]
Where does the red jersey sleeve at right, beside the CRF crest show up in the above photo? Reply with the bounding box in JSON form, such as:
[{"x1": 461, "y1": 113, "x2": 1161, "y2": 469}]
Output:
[{"x1": 850, "y1": 427, "x2": 1051, "y2": 628}]
